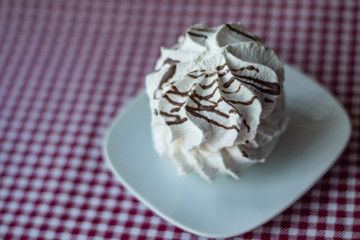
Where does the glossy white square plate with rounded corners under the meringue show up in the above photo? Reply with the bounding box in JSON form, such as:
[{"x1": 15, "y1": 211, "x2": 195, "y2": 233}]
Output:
[{"x1": 104, "y1": 66, "x2": 350, "y2": 237}]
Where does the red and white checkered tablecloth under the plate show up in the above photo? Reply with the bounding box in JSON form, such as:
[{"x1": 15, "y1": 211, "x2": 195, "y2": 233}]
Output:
[{"x1": 0, "y1": 0, "x2": 360, "y2": 239}]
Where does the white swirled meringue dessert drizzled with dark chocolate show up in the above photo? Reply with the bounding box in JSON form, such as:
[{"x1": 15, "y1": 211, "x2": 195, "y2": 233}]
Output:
[{"x1": 146, "y1": 23, "x2": 288, "y2": 181}]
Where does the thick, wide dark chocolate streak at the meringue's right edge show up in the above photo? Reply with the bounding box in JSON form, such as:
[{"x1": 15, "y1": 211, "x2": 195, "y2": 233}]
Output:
[{"x1": 234, "y1": 73, "x2": 280, "y2": 95}]
